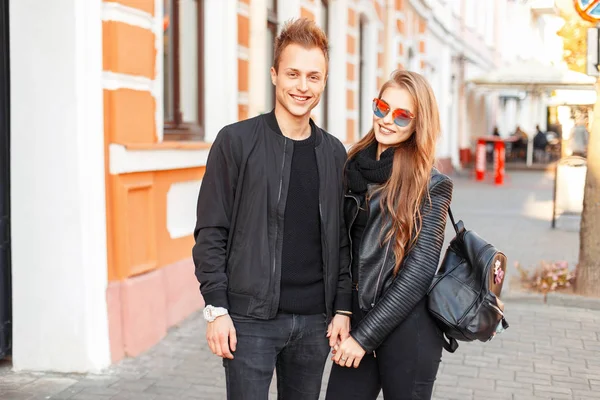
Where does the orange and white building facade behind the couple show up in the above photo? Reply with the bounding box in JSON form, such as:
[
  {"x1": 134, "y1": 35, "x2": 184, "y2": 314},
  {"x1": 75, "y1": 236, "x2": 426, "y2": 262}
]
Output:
[{"x1": 6, "y1": 0, "x2": 552, "y2": 372}]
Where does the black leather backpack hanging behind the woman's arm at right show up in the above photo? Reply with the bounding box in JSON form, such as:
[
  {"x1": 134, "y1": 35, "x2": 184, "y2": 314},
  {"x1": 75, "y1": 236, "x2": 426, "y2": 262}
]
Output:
[{"x1": 428, "y1": 210, "x2": 508, "y2": 353}]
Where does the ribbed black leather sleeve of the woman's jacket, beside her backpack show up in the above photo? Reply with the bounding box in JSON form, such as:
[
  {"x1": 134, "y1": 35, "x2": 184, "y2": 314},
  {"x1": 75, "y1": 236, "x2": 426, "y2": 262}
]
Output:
[{"x1": 350, "y1": 177, "x2": 453, "y2": 352}]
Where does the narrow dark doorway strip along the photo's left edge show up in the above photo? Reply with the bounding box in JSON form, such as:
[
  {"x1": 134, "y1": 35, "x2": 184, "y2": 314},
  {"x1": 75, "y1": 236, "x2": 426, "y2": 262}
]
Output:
[{"x1": 0, "y1": 0, "x2": 12, "y2": 359}]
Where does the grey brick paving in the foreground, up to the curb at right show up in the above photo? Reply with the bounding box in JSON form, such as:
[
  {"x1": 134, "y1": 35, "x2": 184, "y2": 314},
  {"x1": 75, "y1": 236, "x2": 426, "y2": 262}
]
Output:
[{"x1": 0, "y1": 300, "x2": 600, "y2": 400}]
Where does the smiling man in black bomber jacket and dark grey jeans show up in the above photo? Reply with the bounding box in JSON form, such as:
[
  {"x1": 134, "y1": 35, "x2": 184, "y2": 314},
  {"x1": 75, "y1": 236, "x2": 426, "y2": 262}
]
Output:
[{"x1": 193, "y1": 19, "x2": 351, "y2": 400}]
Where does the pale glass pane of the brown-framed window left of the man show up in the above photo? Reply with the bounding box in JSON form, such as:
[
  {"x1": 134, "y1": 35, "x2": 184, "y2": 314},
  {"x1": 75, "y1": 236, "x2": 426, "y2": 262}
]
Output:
[{"x1": 179, "y1": 0, "x2": 198, "y2": 122}]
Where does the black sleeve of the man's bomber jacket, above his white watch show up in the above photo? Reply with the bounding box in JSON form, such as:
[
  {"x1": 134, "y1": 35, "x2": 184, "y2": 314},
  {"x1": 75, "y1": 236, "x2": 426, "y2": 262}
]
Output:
[{"x1": 192, "y1": 128, "x2": 240, "y2": 308}]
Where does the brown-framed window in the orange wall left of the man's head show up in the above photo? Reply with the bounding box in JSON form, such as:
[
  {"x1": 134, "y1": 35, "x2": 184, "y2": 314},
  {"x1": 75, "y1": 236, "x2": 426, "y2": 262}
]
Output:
[{"x1": 163, "y1": 0, "x2": 204, "y2": 140}]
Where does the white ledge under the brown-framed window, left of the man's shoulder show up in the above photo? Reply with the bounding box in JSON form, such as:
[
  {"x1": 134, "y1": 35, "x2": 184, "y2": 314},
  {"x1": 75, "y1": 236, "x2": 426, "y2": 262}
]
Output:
[{"x1": 109, "y1": 143, "x2": 209, "y2": 175}]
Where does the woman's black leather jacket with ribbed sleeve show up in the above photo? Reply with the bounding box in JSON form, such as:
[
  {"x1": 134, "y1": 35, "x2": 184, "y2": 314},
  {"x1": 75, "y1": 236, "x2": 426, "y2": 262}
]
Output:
[{"x1": 344, "y1": 169, "x2": 452, "y2": 352}]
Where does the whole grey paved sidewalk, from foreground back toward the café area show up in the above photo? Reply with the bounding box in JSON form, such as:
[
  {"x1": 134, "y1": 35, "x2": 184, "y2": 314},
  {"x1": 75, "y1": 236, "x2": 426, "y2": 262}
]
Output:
[{"x1": 0, "y1": 171, "x2": 600, "y2": 400}]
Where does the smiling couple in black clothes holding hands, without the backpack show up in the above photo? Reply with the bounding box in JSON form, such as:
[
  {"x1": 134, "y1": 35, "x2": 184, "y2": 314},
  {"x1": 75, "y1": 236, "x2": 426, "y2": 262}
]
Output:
[{"x1": 193, "y1": 19, "x2": 452, "y2": 400}]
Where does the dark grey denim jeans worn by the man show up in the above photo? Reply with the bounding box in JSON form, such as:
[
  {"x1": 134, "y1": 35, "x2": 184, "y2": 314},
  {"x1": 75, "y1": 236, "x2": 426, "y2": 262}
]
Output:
[{"x1": 223, "y1": 314, "x2": 330, "y2": 400}]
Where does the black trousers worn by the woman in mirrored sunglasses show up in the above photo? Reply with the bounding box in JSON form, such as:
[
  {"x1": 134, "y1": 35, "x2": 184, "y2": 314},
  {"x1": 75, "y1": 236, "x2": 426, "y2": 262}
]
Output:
[{"x1": 327, "y1": 292, "x2": 443, "y2": 400}]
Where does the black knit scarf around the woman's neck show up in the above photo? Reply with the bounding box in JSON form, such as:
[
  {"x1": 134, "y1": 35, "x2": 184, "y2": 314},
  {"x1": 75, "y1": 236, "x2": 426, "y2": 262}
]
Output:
[{"x1": 346, "y1": 141, "x2": 396, "y2": 194}]
